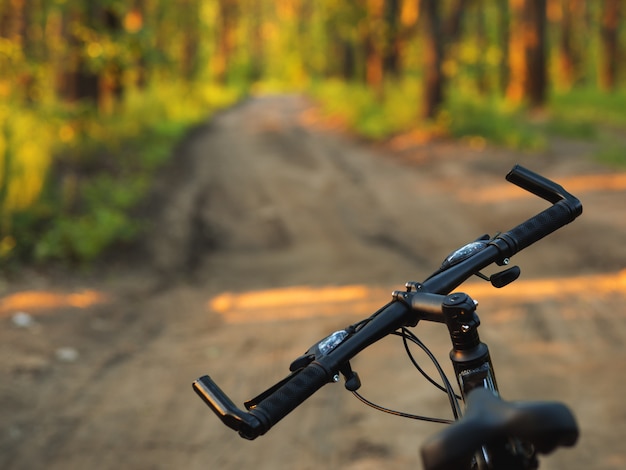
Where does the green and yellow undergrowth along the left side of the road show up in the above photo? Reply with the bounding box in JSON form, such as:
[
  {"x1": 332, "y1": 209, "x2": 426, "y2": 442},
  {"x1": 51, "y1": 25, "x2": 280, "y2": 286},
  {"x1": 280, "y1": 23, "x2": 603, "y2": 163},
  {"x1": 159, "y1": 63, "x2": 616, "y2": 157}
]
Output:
[{"x1": 0, "y1": 83, "x2": 239, "y2": 264}]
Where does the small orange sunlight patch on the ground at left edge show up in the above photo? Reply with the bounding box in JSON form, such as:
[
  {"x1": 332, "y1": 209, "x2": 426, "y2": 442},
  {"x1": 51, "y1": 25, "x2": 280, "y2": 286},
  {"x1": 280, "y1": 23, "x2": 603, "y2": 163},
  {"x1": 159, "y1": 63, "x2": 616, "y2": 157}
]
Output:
[{"x1": 0, "y1": 290, "x2": 109, "y2": 317}]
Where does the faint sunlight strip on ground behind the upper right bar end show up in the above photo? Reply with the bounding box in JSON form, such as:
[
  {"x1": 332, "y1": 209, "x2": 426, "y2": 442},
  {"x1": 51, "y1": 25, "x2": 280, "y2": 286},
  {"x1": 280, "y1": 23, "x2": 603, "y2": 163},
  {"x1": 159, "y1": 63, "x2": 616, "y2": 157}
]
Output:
[{"x1": 460, "y1": 173, "x2": 626, "y2": 203}]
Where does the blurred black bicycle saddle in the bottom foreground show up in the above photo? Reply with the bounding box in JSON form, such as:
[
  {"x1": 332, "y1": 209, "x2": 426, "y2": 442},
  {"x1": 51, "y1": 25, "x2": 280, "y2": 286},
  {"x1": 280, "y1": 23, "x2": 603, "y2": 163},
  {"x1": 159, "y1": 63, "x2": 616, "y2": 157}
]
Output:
[{"x1": 421, "y1": 388, "x2": 578, "y2": 470}]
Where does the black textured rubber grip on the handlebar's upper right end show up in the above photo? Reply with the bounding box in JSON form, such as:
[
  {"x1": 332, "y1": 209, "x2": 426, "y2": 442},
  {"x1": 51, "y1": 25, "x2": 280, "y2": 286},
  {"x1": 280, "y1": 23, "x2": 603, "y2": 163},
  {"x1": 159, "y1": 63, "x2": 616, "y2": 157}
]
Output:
[{"x1": 495, "y1": 201, "x2": 579, "y2": 258}]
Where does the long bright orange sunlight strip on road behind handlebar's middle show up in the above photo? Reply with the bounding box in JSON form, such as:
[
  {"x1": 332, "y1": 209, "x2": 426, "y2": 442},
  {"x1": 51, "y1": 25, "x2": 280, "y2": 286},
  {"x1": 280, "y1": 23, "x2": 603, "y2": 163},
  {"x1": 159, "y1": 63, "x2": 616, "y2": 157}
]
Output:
[{"x1": 207, "y1": 270, "x2": 626, "y2": 323}]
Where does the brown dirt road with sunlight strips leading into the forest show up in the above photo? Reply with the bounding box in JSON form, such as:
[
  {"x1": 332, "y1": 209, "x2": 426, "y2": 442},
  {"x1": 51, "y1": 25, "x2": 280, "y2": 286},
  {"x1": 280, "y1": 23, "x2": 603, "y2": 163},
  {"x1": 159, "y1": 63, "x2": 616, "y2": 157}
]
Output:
[{"x1": 0, "y1": 96, "x2": 626, "y2": 470}]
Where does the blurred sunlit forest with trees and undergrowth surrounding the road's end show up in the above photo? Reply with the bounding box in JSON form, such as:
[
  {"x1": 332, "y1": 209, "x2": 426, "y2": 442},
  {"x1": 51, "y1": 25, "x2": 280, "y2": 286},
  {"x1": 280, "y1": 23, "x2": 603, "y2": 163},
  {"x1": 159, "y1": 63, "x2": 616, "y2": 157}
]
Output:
[{"x1": 0, "y1": 0, "x2": 626, "y2": 266}]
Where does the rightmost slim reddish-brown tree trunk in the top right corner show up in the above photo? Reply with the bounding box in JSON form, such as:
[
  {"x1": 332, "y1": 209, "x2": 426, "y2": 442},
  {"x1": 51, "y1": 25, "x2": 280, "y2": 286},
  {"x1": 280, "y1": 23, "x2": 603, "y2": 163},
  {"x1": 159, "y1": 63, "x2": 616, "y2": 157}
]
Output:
[{"x1": 600, "y1": 0, "x2": 621, "y2": 91}]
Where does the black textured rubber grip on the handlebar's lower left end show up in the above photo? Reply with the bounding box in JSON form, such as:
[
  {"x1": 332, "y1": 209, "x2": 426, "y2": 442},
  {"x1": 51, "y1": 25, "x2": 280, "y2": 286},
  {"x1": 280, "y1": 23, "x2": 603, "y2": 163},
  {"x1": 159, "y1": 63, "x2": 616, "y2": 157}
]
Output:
[{"x1": 242, "y1": 362, "x2": 332, "y2": 439}]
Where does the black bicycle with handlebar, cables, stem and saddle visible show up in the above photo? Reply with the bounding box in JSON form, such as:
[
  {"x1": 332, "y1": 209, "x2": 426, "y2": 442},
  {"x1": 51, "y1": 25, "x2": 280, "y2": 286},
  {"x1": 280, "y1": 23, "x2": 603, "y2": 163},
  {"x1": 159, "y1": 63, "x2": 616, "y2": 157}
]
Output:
[{"x1": 193, "y1": 165, "x2": 582, "y2": 470}]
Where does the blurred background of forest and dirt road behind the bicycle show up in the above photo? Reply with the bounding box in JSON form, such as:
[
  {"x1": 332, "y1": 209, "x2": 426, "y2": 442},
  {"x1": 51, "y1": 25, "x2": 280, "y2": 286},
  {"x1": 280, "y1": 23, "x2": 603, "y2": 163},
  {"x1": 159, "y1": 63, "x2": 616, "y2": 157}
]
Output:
[{"x1": 0, "y1": 0, "x2": 626, "y2": 470}]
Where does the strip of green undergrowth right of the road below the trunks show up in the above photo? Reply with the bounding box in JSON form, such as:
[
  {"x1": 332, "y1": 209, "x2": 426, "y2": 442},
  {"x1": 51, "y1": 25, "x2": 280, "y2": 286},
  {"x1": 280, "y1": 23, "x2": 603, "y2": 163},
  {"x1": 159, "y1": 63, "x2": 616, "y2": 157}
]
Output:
[{"x1": 311, "y1": 78, "x2": 626, "y2": 170}]
